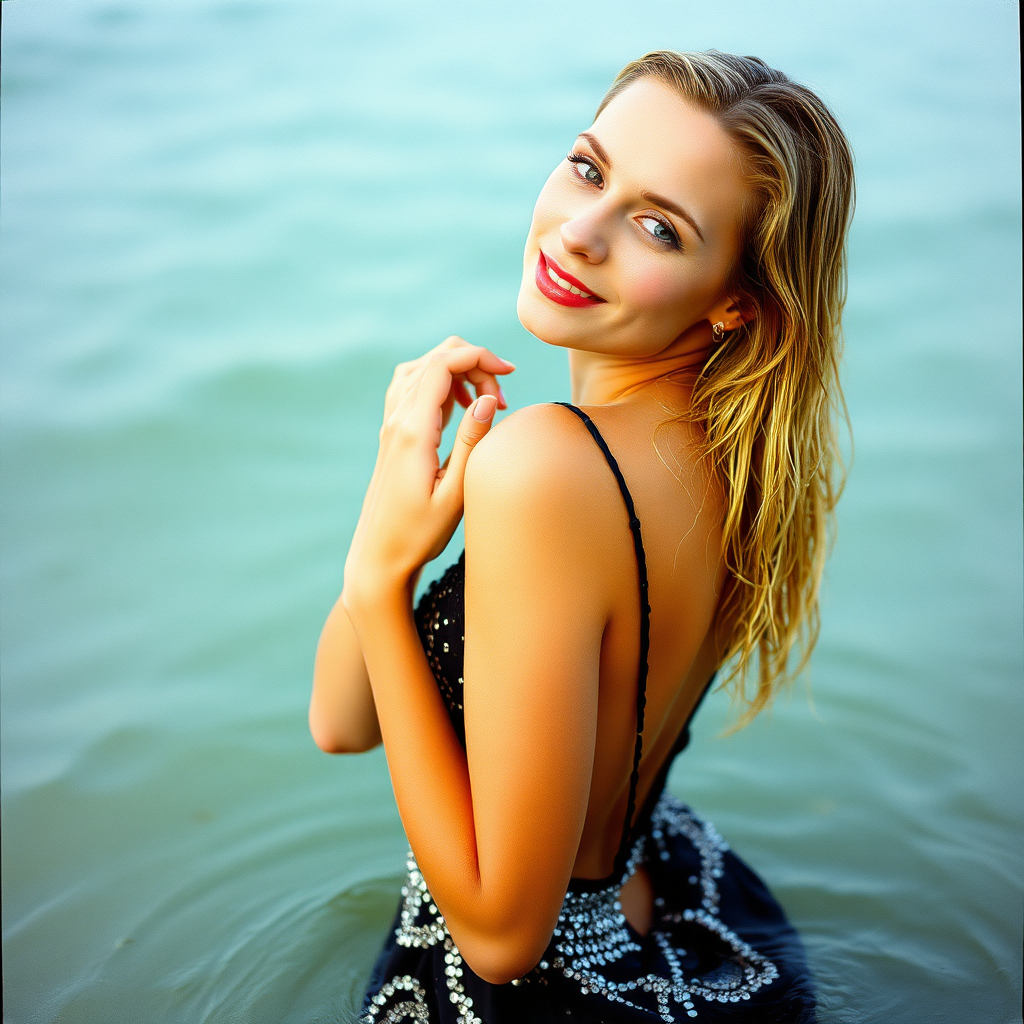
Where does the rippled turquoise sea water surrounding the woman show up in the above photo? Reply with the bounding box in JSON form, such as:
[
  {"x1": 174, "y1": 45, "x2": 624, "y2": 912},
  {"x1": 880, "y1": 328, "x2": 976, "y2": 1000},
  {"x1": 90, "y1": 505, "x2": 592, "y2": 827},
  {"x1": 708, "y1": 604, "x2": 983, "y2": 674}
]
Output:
[{"x1": 0, "y1": 0, "x2": 1024, "y2": 1024}]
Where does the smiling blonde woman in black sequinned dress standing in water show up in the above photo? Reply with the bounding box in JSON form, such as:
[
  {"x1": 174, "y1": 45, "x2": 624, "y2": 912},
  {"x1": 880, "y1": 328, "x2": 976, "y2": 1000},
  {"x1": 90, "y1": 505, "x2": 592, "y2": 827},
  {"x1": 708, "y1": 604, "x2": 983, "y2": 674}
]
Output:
[{"x1": 309, "y1": 51, "x2": 853, "y2": 1024}]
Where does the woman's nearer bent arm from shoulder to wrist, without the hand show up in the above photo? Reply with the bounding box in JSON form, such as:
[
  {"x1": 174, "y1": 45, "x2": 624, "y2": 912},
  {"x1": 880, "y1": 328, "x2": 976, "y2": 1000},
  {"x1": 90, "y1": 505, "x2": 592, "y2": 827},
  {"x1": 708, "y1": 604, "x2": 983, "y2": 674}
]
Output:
[{"x1": 345, "y1": 407, "x2": 608, "y2": 983}]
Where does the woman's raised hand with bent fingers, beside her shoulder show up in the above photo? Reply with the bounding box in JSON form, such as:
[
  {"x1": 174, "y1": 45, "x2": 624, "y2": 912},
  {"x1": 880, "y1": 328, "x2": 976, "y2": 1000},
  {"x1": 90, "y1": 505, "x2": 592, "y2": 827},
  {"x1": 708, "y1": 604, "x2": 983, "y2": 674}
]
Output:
[{"x1": 342, "y1": 338, "x2": 515, "y2": 613}]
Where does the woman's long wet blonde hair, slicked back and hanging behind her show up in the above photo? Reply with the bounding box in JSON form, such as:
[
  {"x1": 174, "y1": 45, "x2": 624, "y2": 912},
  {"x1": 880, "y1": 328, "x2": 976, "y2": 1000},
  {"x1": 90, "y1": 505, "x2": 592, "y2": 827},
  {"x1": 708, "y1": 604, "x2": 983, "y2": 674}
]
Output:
[{"x1": 597, "y1": 50, "x2": 854, "y2": 728}]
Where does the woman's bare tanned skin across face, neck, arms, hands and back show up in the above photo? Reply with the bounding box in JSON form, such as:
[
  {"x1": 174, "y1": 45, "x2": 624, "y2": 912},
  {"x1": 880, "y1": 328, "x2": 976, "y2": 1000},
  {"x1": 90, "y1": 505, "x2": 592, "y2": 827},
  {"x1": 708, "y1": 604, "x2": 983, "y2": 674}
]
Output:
[{"x1": 309, "y1": 79, "x2": 754, "y2": 984}]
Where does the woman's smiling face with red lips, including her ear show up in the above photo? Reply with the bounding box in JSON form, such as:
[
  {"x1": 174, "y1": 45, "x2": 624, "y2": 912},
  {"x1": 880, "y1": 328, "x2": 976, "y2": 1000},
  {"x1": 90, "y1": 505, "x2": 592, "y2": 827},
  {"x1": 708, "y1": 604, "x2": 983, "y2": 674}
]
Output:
[{"x1": 518, "y1": 78, "x2": 748, "y2": 357}]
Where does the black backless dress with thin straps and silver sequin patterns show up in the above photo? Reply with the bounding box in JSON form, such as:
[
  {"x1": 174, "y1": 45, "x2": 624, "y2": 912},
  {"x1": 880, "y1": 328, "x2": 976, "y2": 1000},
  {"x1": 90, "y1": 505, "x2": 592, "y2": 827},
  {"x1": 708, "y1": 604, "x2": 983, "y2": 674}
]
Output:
[{"x1": 360, "y1": 402, "x2": 815, "y2": 1024}]
